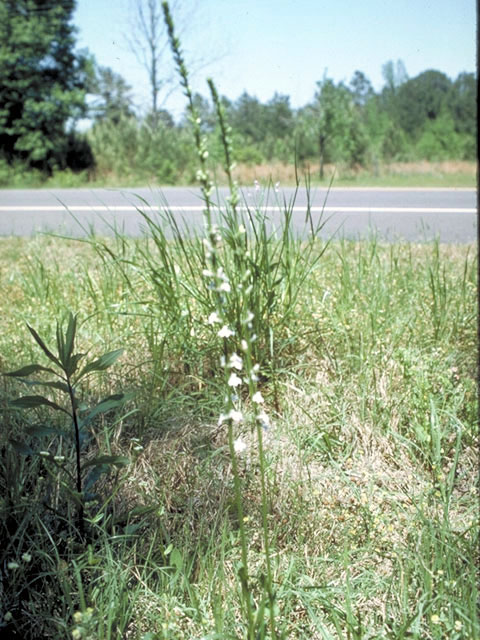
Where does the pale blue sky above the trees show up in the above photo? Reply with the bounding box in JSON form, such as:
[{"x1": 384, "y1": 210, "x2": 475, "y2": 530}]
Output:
[{"x1": 74, "y1": 0, "x2": 477, "y2": 119}]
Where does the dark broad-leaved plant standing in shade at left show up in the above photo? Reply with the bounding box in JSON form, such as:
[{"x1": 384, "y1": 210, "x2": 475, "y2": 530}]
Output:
[{"x1": 3, "y1": 313, "x2": 129, "y2": 539}]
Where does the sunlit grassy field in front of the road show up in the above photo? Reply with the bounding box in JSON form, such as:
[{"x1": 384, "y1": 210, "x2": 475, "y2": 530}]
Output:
[{"x1": 0, "y1": 196, "x2": 480, "y2": 640}]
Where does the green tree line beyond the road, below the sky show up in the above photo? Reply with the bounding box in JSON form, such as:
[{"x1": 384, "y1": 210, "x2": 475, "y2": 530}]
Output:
[{"x1": 0, "y1": 0, "x2": 477, "y2": 183}]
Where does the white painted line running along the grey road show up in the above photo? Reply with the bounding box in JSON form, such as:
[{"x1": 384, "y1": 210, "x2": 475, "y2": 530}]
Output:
[{"x1": 0, "y1": 205, "x2": 477, "y2": 213}]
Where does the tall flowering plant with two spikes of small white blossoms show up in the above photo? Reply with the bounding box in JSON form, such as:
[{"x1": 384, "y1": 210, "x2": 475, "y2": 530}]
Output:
[{"x1": 162, "y1": 2, "x2": 277, "y2": 640}]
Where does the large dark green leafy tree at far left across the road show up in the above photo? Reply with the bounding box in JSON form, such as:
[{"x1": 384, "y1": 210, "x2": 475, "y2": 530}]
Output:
[{"x1": 0, "y1": 0, "x2": 91, "y2": 173}]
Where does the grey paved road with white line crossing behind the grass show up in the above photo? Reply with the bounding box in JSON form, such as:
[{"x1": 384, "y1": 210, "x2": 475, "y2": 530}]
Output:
[{"x1": 0, "y1": 187, "x2": 477, "y2": 243}]
